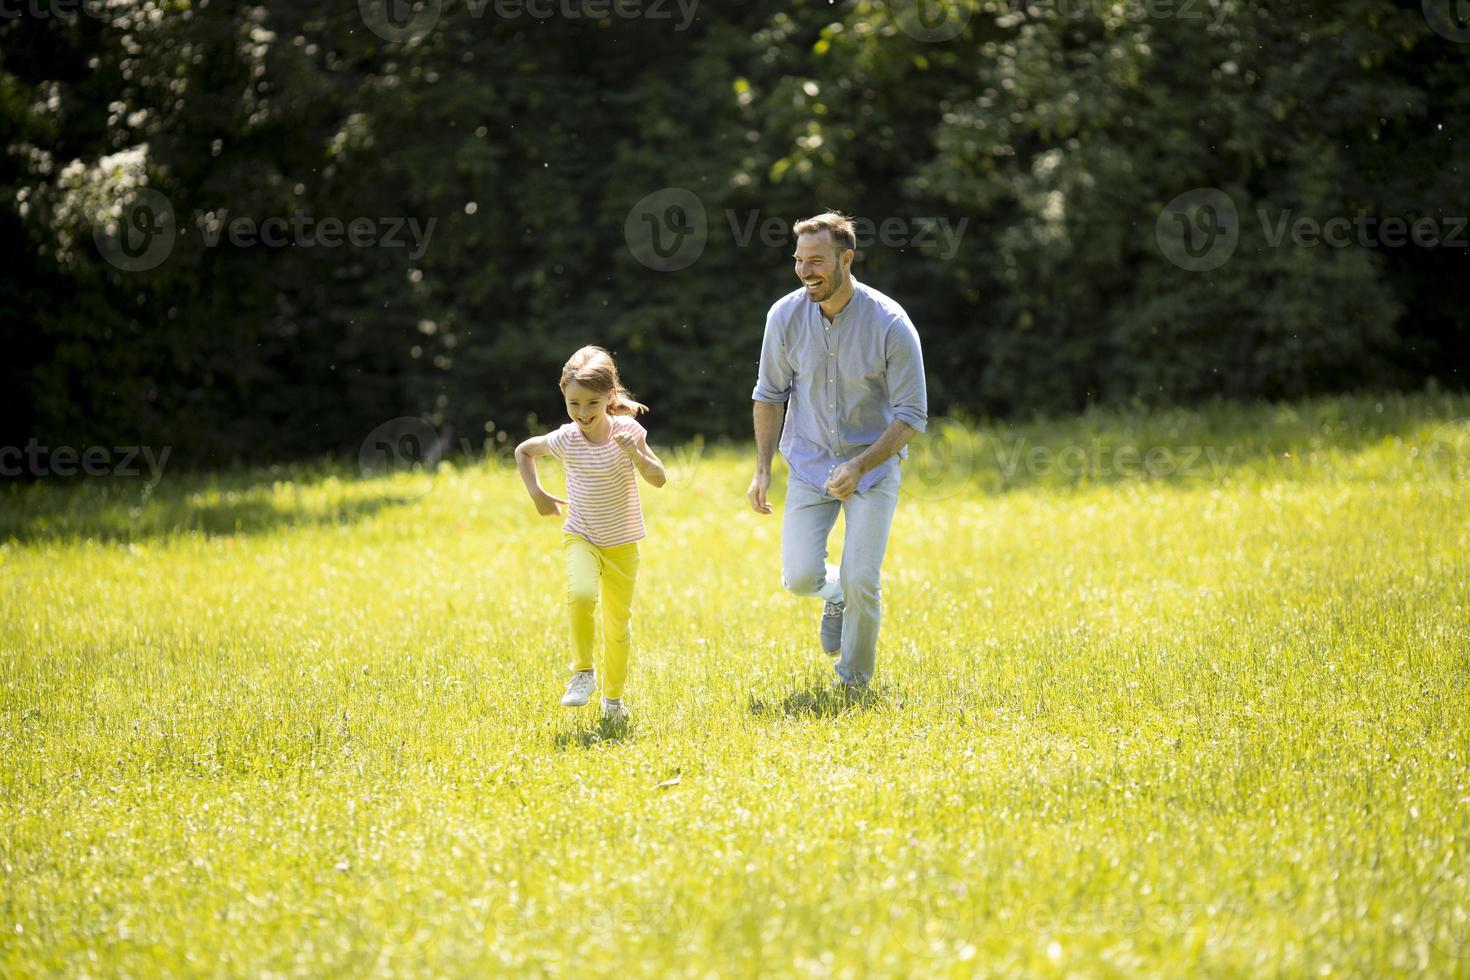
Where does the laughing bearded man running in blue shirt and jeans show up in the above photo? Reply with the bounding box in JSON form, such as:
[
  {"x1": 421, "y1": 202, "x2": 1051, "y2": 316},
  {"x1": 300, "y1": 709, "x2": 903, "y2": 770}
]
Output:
[{"x1": 747, "y1": 213, "x2": 929, "y2": 691}]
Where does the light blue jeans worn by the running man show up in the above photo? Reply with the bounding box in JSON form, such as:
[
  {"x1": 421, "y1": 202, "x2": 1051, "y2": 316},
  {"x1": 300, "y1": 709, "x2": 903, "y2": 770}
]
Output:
[{"x1": 781, "y1": 466, "x2": 901, "y2": 685}]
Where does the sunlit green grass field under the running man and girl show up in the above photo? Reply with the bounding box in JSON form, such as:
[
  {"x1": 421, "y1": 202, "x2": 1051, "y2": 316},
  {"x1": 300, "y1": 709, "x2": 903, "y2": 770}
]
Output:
[{"x1": 0, "y1": 395, "x2": 1470, "y2": 977}]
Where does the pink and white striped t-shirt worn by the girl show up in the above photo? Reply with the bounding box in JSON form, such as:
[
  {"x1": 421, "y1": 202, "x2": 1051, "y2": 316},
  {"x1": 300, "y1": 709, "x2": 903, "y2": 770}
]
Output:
[{"x1": 547, "y1": 416, "x2": 648, "y2": 548}]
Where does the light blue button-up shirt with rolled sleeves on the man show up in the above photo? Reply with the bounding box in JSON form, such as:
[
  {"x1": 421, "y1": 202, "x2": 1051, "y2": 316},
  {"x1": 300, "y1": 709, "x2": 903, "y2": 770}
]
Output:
[{"x1": 751, "y1": 279, "x2": 929, "y2": 492}]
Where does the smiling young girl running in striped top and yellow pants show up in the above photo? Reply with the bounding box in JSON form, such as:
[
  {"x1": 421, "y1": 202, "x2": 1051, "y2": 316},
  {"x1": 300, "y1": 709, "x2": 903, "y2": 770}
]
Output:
[{"x1": 516, "y1": 347, "x2": 666, "y2": 721}]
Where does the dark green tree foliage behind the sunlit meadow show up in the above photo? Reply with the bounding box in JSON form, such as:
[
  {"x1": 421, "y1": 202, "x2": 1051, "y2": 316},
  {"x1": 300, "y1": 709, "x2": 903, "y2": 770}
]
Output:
[{"x1": 0, "y1": 0, "x2": 1470, "y2": 464}]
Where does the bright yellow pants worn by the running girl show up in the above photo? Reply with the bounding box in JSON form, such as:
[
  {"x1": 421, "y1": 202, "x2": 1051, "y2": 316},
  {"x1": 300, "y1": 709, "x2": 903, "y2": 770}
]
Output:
[{"x1": 562, "y1": 533, "x2": 638, "y2": 698}]
